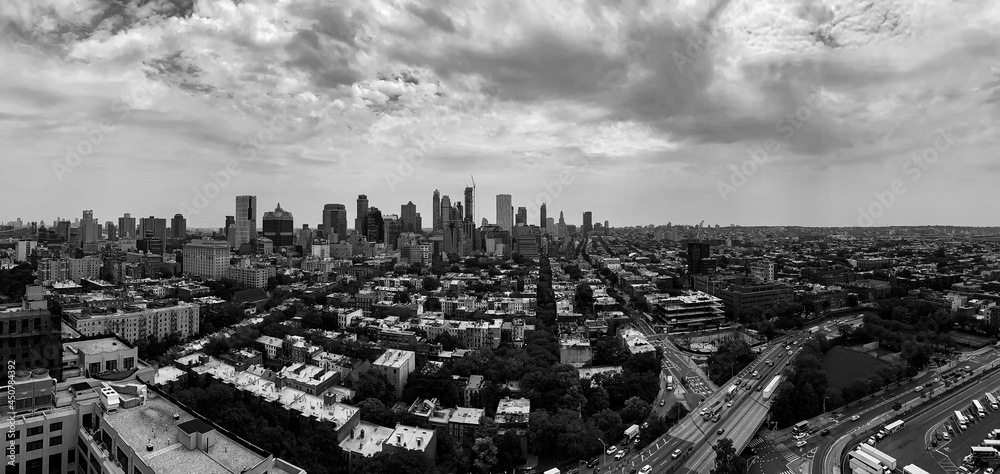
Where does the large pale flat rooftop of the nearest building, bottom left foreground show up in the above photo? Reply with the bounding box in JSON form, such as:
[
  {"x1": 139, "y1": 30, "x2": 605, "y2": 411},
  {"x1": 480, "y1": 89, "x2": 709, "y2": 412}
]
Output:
[{"x1": 104, "y1": 386, "x2": 265, "y2": 474}]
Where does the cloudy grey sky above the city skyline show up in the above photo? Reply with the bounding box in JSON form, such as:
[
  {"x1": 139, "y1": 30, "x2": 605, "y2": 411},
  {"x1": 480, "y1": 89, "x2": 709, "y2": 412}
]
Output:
[{"x1": 0, "y1": 0, "x2": 1000, "y2": 227}]
